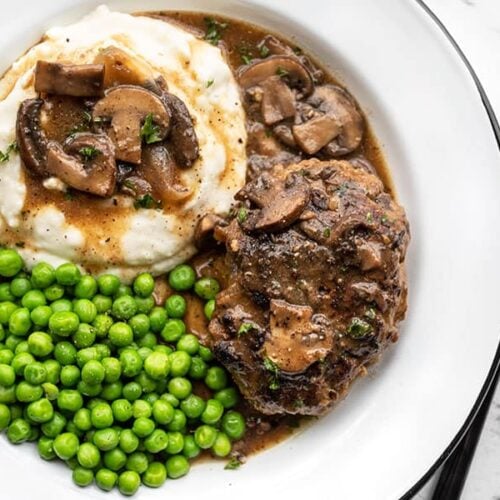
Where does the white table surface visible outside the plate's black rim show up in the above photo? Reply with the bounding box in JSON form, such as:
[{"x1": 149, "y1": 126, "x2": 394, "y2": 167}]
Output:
[{"x1": 415, "y1": 0, "x2": 500, "y2": 500}]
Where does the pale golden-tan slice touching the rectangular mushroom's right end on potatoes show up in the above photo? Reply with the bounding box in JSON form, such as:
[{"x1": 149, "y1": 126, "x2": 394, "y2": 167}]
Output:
[{"x1": 94, "y1": 46, "x2": 161, "y2": 93}]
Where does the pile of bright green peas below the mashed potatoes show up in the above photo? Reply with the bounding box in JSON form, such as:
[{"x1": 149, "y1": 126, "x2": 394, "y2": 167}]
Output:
[{"x1": 0, "y1": 248, "x2": 245, "y2": 495}]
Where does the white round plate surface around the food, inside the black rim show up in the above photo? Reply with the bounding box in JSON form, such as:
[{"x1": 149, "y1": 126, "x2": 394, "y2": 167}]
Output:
[{"x1": 0, "y1": 0, "x2": 500, "y2": 500}]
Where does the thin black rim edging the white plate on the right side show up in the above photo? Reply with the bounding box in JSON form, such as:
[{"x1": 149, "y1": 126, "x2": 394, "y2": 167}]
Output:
[{"x1": 399, "y1": 0, "x2": 500, "y2": 500}]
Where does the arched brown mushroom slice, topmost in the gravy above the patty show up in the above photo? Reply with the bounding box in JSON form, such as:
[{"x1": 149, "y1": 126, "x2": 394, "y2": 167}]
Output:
[{"x1": 238, "y1": 56, "x2": 314, "y2": 96}]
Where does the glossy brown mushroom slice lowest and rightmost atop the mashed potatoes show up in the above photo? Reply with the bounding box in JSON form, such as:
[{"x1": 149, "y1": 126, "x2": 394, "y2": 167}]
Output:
[{"x1": 140, "y1": 144, "x2": 191, "y2": 203}]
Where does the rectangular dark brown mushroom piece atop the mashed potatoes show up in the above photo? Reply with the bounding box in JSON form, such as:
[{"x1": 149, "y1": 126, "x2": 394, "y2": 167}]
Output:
[{"x1": 35, "y1": 61, "x2": 104, "y2": 97}]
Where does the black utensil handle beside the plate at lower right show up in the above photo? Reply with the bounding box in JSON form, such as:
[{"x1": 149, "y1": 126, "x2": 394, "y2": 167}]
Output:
[{"x1": 432, "y1": 370, "x2": 500, "y2": 500}]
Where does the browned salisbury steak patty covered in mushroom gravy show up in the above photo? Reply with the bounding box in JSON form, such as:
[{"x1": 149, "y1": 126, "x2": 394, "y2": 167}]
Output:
[{"x1": 210, "y1": 160, "x2": 409, "y2": 415}]
